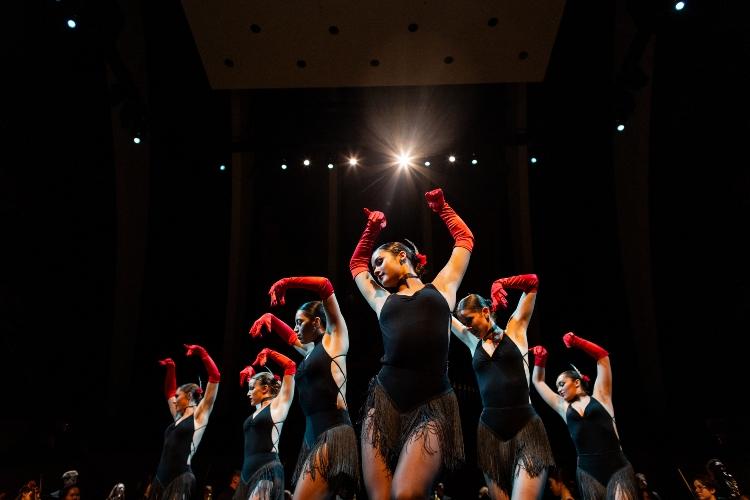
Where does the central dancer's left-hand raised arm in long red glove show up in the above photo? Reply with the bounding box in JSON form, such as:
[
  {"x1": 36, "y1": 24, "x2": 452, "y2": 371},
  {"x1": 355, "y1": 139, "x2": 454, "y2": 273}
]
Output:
[{"x1": 349, "y1": 208, "x2": 390, "y2": 316}]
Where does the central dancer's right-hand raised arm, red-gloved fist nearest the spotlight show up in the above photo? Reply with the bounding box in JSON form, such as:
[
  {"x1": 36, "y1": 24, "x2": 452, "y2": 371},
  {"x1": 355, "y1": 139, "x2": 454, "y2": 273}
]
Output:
[{"x1": 425, "y1": 189, "x2": 474, "y2": 309}]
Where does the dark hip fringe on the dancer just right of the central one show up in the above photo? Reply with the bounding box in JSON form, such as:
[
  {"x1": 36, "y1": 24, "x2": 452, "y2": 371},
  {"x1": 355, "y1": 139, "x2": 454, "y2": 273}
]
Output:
[{"x1": 477, "y1": 416, "x2": 555, "y2": 494}]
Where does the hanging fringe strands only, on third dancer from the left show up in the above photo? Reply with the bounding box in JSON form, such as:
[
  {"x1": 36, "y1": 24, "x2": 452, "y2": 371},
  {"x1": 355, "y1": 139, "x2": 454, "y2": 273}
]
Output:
[{"x1": 292, "y1": 425, "x2": 360, "y2": 497}]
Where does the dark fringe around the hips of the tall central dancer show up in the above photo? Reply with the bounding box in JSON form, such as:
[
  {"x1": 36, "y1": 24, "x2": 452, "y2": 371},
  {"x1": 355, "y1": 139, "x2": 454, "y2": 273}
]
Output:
[{"x1": 362, "y1": 377, "x2": 464, "y2": 477}]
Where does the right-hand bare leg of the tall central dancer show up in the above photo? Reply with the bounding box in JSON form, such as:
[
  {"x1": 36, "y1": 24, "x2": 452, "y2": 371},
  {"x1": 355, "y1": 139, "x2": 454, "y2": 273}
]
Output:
[{"x1": 392, "y1": 422, "x2": 443, "y2": 500}]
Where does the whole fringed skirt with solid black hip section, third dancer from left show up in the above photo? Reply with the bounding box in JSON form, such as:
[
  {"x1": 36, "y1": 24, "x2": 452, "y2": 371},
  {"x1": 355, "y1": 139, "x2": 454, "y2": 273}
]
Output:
[{"x1": 292, "y1": 410, "x2": 359, "y2": 498}]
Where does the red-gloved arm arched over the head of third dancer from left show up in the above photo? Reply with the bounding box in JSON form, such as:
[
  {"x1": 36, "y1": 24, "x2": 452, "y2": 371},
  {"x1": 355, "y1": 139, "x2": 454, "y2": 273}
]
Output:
[{"x1": 268, "y1": 276, "x2": 349, "y2": 354}]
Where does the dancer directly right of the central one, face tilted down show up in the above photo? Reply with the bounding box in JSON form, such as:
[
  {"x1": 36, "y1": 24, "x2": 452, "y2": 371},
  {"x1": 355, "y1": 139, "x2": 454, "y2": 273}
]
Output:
[{"x1": 451, "y1": 274, "x2": 554, "y2": 500}]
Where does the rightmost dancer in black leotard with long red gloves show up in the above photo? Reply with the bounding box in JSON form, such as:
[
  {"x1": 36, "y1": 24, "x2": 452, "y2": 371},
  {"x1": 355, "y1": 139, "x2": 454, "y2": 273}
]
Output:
[{"x1": 531, "y1": 332, "x2": 638, "y2": 500}]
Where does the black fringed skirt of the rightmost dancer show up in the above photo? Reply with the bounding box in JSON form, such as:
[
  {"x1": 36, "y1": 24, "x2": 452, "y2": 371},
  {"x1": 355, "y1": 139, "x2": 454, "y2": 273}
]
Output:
[{"x1": 576, "y1": 450, "x2": 640, "y2": 500}]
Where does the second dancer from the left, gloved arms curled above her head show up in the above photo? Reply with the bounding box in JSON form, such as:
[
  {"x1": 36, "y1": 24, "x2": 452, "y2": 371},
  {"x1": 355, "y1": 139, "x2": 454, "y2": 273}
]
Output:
[{"x1": 232, "y1": 348, "x2": 296, "y2": 500}]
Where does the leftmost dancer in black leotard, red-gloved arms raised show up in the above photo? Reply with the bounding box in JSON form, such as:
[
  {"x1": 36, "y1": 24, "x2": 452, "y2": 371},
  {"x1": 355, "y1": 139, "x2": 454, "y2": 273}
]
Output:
[{"x1": 150, "y1": 345, "x2": 221, "y2": 500}]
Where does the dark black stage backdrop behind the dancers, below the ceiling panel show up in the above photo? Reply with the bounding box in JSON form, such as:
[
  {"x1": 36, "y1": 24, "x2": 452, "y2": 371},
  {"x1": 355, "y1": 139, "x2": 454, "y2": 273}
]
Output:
[{"x1": 5, "y1": 0, "x2": 750, "y2": 498}]
